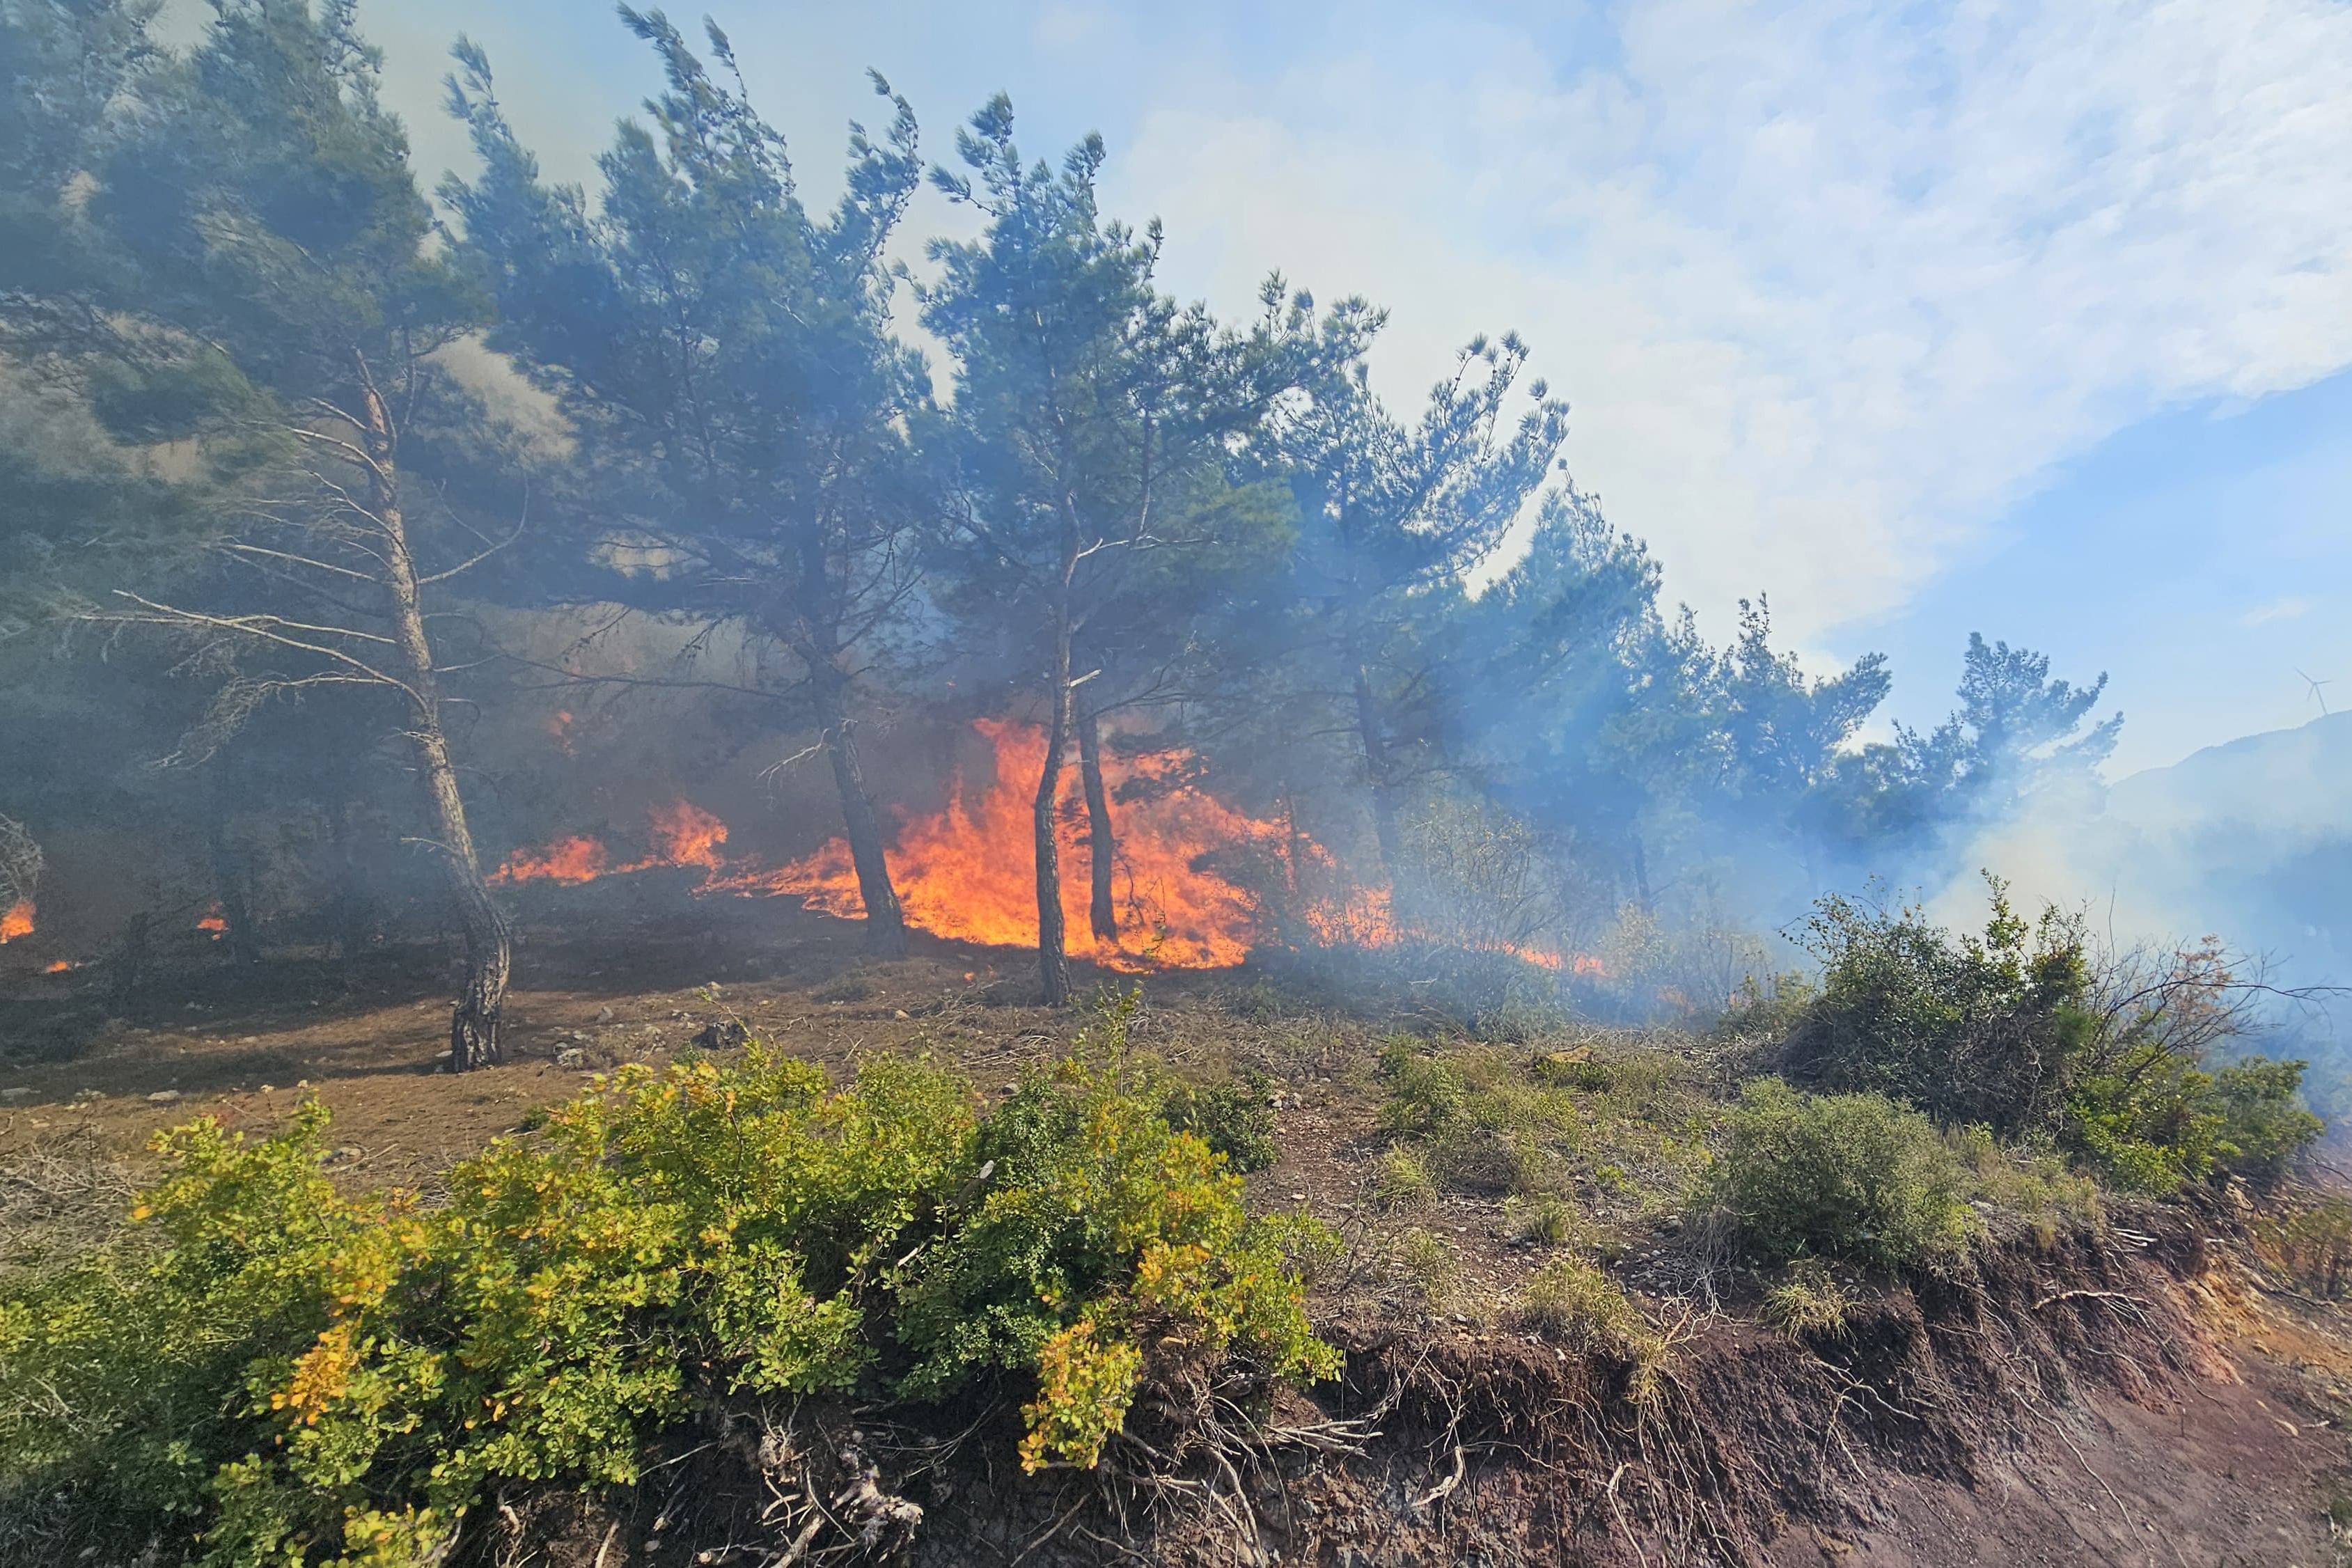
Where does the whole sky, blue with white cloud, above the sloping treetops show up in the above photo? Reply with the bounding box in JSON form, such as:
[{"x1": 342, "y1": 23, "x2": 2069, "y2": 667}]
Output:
[{"x1": 347, "y1": 0, "x2": 2352, "y2": 771}]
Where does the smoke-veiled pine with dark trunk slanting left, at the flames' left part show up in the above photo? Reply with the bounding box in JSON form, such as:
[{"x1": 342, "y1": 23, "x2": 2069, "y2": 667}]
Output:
[{"x1": 444, "y1": 7, "x2": 929, "y2": 955}]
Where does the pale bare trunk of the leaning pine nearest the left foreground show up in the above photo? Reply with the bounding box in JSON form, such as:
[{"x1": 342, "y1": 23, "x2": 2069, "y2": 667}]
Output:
[{"x1": 353, "y1": 355, "x2": 515, "y2": 1072}]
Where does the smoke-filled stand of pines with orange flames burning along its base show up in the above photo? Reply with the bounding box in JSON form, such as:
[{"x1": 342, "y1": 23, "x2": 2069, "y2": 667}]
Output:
[{"x1": 0, "y1": 5, "x2": 2352, "y2": 1100}]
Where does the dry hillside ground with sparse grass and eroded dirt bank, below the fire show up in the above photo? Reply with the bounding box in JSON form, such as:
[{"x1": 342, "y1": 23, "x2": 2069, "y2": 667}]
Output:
[{"x1": 0, "y1": 891, "x2": 2352, "y2": 1568}]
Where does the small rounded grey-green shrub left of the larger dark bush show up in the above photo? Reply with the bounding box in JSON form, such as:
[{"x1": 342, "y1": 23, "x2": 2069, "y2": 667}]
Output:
[{"x1": 1700, "y1": 1079, "x2": 1980, "y2": 1267}]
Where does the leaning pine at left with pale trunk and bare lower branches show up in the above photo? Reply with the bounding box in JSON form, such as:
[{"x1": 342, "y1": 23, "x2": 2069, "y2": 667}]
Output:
[{"x1": 24, "y1": 0, "x2": 520, "y2": 1069}]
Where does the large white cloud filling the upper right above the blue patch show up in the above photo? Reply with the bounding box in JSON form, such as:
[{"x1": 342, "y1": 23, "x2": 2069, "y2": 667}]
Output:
[{"x1": 1110, "y1": 0, "x2": 2352, "y2": 639}]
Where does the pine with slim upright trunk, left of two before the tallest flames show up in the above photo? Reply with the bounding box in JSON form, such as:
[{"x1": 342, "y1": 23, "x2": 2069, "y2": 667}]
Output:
[{"x1": 922, "y1": 96, "x2": 1301, "y2": 1006}]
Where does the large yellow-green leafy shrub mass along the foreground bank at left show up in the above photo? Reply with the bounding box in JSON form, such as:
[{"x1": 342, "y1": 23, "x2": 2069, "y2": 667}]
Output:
[{"x1": 0, "y1": 1008, "x2": 1336, "y2": 1563}]
